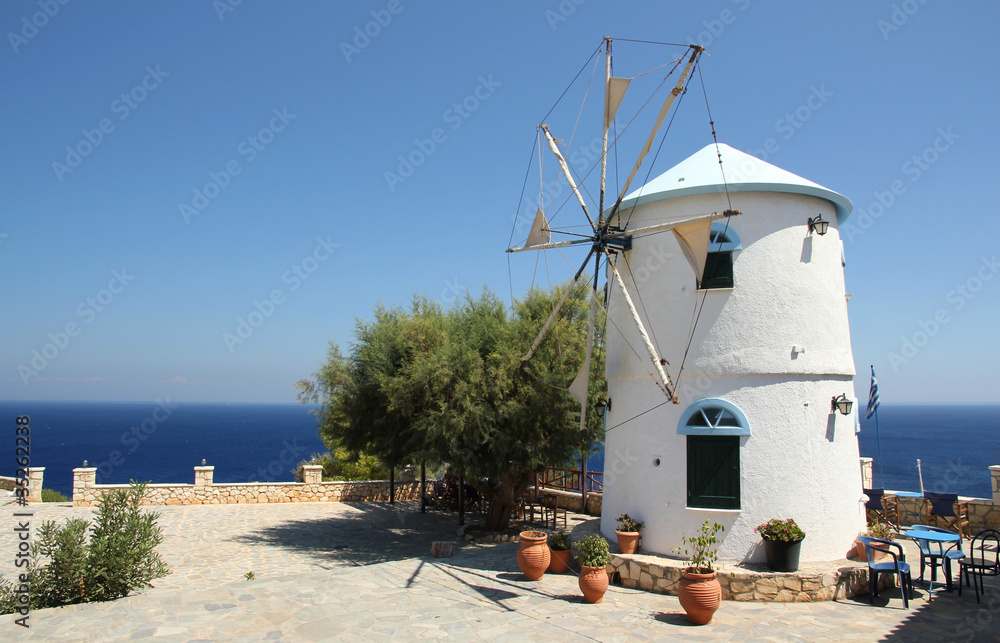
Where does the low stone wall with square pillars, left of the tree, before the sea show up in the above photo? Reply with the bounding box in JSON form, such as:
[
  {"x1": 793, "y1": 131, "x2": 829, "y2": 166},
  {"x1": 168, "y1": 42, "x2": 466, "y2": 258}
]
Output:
[{"x1": 73, "y1": 465, "x2": 420, "y2": 507}]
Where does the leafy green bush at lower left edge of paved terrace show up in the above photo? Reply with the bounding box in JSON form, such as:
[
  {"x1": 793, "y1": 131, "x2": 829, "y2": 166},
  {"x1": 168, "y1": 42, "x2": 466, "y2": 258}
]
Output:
[{"x1": 0, "y1": 481, "x2": 169, "y2": 614}]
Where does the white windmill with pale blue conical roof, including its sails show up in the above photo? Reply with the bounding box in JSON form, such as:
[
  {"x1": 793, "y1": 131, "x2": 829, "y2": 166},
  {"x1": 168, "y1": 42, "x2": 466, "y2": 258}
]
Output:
[{"x1": 511, "y1": 39, "x2": 864, "y2": 561}]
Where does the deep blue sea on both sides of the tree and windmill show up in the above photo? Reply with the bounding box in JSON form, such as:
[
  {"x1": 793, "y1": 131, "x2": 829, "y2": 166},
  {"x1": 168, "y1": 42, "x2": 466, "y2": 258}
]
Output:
[{"x1": 0, "y1": 401, "x2": 1000, "y2": 498}]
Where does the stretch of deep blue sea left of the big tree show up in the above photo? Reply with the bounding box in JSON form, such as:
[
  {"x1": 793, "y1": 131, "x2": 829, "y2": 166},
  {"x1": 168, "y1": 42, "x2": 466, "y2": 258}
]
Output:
[{"x1": 0, "y1": 401, "x2": 326, "y2": 496}]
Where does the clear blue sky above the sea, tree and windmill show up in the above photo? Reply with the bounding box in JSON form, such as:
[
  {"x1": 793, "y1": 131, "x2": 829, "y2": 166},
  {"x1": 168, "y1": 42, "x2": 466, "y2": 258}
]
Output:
[{"x1": 0, "y1": 0, "x2": 1000, "y2": 403}]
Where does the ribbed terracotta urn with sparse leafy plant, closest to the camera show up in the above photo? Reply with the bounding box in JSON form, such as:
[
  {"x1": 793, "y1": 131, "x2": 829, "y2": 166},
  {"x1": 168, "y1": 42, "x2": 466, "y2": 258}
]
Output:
[{"x1": 673, "y1": 520, "x2": 725, "y2": 625}]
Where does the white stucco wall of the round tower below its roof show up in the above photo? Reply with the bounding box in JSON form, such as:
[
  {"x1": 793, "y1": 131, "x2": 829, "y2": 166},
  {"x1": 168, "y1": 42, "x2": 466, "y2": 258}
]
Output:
[{"x1": 601, "y1": 187, "x2": 864, "y2": 561}]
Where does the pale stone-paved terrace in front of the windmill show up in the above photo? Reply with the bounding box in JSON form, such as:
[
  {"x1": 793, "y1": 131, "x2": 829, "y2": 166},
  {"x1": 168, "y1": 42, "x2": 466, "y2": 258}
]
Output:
[{"x1": 0, "y1": 503, "x2": 1000, "y2": 641}]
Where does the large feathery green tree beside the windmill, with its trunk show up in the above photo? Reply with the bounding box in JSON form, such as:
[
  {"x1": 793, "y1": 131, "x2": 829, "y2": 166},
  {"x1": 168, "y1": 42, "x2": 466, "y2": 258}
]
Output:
[{"x1": 299, "y1": 284, "x2": 605, "y2": 529}]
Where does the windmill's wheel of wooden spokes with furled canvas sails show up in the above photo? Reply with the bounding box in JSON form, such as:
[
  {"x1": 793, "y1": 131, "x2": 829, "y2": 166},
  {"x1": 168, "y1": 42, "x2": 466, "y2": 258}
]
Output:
[{"x1": 507, "y1": 38, "x2": 739, "y2": 442}]
